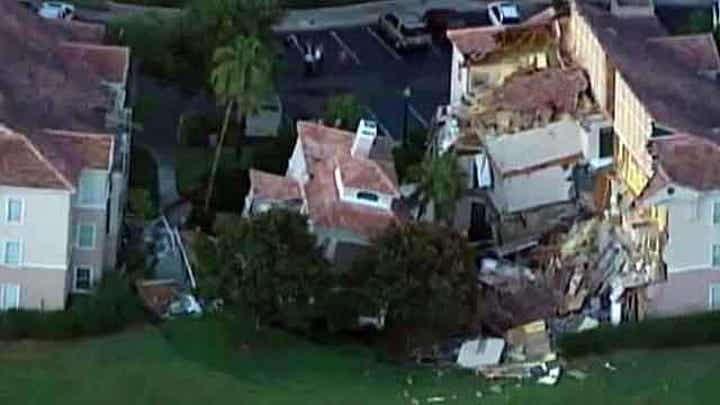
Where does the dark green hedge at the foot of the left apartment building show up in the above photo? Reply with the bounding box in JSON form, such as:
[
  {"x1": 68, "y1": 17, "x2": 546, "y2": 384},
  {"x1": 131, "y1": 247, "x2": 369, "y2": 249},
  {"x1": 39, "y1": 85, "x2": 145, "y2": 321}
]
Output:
[{"x1": 0, "y1": 273, "x2": 145, "y2": 340}]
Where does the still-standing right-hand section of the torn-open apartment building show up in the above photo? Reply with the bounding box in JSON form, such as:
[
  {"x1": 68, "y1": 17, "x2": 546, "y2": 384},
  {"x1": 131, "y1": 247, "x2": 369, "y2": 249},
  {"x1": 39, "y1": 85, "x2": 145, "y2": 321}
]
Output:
[{"x1": 564, "y1": 0, "x2": 720, "y2": 316}]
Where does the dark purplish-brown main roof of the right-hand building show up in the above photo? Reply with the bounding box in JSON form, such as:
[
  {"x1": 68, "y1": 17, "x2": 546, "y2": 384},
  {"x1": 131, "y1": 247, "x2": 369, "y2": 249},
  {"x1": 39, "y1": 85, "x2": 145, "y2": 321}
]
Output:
[{"x1": 576, "y1": 0, "x2": 720, "y2": 143}]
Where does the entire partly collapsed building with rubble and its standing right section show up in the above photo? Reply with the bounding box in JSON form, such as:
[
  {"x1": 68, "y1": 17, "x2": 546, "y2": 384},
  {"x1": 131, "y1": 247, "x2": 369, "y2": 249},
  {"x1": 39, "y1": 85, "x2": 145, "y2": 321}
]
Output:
[{"x1": 432, "y1": 0, "x2": 720, "y2": 330}]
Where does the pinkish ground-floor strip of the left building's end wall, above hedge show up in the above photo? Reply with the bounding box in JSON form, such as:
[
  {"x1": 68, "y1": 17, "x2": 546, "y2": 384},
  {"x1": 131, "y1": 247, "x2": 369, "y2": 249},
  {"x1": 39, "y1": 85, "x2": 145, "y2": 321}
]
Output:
[{"x1": 0, "y1": 266, "x2": 68, "y2": 310}]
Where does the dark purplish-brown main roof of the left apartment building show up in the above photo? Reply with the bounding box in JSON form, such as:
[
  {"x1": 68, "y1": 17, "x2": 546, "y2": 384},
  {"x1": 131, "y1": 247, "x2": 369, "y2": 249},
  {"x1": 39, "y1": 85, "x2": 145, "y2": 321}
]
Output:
[{"x1": 0, "y1": 0, "x2": 124, "y2": 132}]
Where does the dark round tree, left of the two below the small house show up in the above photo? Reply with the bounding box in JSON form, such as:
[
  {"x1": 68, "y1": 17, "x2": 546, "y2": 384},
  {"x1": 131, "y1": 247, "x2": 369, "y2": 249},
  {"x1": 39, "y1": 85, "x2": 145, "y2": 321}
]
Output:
[{"x1": 193, "y1": 210, "x2": 330, "y2": 327}]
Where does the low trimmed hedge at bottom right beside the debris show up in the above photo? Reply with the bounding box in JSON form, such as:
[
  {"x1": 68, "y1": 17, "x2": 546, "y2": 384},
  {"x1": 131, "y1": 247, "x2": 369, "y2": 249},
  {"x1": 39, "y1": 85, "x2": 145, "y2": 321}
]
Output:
[{"x1": 558, "y1": 312, "x2": 720, "y2": 357}]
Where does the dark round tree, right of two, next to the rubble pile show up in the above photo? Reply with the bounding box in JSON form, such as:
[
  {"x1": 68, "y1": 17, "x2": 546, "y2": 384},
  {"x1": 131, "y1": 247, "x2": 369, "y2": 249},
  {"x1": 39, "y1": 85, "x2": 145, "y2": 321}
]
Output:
[{"x1": 348, "y1": 224, "x2": 477, "y2": 338}]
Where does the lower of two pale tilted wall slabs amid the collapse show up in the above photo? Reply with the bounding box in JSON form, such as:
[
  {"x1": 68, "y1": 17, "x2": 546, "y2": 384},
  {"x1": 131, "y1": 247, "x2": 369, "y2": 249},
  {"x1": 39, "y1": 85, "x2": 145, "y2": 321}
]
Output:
[{"x1": 490, "y1": 166, "x2": 572, "y2": 214}]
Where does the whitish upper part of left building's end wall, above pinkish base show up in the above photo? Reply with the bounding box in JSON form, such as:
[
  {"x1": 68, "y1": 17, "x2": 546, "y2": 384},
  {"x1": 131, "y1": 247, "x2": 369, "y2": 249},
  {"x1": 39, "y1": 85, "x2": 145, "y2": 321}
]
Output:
[{"x1": 0, "y1": 186, "x2": 71, "y2": 269}]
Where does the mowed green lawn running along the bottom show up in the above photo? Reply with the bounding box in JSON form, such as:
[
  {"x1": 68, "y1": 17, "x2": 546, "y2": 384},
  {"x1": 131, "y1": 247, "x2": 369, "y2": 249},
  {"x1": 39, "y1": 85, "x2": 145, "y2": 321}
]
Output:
[{"x1": 0, "y1": 319, "x2": 720, "y2": 405}]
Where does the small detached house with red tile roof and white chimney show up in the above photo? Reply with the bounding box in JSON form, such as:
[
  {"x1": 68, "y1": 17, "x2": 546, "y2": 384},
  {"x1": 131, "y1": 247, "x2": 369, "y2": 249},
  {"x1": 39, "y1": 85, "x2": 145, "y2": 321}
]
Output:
[{"x1": 244, "y1": 120, "x2": 401, "y2": 265}]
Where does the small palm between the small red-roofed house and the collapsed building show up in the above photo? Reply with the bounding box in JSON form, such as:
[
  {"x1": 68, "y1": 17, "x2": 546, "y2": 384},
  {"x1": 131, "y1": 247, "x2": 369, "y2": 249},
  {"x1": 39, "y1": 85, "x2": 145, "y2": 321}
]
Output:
[{"x1": 409, "y1": 153, "x2": 467, "y2": 223}]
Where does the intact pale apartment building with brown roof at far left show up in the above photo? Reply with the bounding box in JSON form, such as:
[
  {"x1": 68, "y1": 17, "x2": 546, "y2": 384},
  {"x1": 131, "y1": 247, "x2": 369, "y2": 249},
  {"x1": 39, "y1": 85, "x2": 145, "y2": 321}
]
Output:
[{"x1": 0, "y1": 2, "x2": 130, "y2": 310}]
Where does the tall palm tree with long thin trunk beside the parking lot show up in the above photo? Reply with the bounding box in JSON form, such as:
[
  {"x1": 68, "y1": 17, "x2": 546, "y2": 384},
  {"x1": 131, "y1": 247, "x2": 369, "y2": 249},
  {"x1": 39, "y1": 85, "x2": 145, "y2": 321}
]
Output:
[{"x1": 205, "y1": 36, "x2": 272, "y2": 212}]
